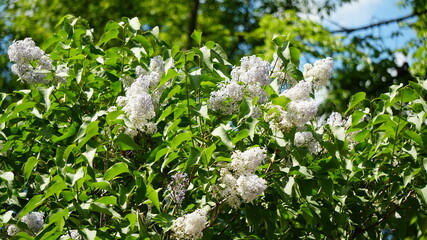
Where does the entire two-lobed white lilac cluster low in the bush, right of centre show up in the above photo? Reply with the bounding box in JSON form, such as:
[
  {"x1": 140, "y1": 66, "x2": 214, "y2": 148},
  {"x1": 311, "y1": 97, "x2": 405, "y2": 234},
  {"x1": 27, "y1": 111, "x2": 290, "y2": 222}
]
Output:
[{"x1": 218, "y1": 147, "x2": 267, "y2": 208}]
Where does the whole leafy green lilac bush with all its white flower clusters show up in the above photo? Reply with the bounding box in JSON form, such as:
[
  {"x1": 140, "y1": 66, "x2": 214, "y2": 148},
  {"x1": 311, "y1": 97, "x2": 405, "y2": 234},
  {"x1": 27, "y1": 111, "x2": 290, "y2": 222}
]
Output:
[{"x1": 0, "y1": 16, "x2": 427, "y2": 239}]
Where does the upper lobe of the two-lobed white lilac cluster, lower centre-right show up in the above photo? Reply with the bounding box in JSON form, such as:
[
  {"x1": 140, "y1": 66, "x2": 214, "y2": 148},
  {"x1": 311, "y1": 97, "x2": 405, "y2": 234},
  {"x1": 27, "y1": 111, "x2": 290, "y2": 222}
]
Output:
[{"x1": 230, "y1": 147, "x2": 267, "y2": 175}]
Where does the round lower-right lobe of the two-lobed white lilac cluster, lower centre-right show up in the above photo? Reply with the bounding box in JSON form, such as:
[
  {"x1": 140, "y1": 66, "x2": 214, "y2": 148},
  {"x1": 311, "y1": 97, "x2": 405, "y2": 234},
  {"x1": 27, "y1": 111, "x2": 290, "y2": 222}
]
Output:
[{"x1": 237, "y1": 174, "x2": 267, "y2": 202}]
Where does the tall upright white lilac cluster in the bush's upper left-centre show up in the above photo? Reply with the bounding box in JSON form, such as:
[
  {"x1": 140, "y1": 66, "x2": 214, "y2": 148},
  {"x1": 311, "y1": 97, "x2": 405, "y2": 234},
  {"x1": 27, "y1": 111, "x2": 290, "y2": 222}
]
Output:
[{"x1": 117, "y1": 56, "x2": 167, "y2": 135}]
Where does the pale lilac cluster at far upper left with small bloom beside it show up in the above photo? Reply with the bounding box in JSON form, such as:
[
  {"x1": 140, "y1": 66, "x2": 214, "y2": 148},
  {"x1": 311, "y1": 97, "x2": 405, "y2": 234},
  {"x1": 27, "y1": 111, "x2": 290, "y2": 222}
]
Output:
[{"x1": 7, "y1": 38, "x2": 68, "y2": 84}]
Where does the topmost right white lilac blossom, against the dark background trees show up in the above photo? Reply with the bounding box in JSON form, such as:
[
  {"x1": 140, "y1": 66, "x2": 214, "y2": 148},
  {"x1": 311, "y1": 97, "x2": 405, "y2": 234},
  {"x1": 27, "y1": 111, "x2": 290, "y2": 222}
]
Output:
[{"x1": 304, "y1": 57, "x2": 334, "y2": 86}]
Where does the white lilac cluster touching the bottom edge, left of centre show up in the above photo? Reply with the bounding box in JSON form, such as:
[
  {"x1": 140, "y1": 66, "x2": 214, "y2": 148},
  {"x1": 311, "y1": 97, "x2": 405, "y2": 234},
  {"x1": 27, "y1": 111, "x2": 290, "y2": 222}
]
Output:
[{"x1": 172, "y1": 209, "x2": 207, "y2": 240}]
